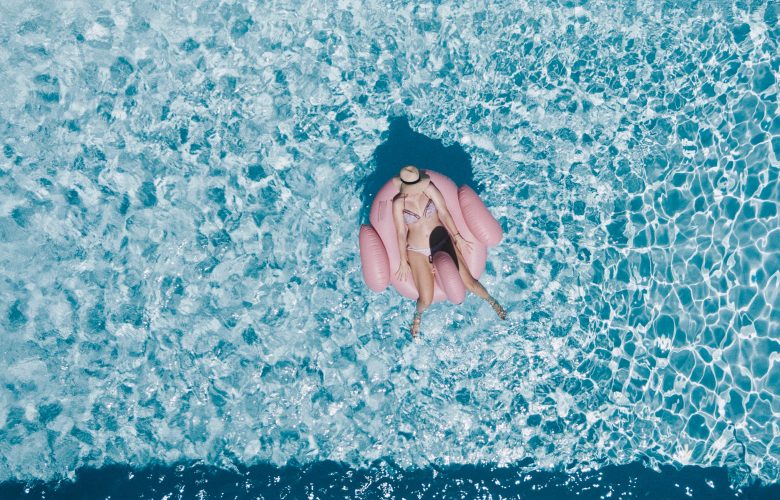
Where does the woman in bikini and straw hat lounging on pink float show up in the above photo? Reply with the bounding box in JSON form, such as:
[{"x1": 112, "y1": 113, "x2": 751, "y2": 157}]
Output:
[{"x1": 393, "y1": 165, "x2": 506, "y2": 337}]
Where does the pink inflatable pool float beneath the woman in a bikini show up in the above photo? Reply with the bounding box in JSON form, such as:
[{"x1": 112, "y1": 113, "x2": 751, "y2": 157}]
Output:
[{"x1": 359, "y1": 170, "x2": 503, "y2": 304}]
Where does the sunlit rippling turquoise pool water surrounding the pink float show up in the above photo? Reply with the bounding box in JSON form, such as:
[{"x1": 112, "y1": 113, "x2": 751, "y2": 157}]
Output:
[{"x1": 0, "y1": 0, "x2": 780, "y2": 494}]
